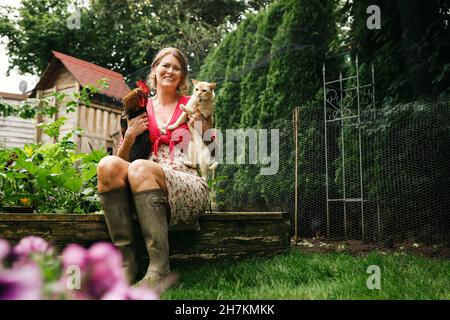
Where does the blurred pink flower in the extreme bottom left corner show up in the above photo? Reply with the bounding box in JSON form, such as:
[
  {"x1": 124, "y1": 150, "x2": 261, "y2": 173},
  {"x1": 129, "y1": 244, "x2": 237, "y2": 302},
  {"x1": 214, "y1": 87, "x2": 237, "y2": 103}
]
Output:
[{"x1": 0, "y1": 264, "x2": 42, "y2": 300}]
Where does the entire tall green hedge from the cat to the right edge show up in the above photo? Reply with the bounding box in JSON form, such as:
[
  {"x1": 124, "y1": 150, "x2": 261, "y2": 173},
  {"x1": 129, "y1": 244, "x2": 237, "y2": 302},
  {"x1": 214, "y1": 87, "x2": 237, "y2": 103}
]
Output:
[{"x1": 194, "y1": 0, "x2": 450, "y2": 241}]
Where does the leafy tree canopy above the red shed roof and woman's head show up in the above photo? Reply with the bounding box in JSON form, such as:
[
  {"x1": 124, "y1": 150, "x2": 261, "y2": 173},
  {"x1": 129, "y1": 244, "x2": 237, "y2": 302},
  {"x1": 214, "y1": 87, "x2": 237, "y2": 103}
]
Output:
[{"x1": 0, "y1": 0, "x2": 268, "y2": 79}]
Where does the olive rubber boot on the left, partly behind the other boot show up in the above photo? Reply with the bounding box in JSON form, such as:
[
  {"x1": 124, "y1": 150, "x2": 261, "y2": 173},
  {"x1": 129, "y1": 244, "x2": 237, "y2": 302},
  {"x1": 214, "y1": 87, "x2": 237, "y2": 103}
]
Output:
[{"x1": 98, "y1": 187, "x2": 139, "y2": 284}]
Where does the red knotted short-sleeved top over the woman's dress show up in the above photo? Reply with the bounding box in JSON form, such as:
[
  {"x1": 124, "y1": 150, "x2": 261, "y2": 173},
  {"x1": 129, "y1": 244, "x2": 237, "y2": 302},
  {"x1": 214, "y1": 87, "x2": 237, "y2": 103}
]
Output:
[{"x1": 147, "y1": 96, "x2": 190, "y2": 162}]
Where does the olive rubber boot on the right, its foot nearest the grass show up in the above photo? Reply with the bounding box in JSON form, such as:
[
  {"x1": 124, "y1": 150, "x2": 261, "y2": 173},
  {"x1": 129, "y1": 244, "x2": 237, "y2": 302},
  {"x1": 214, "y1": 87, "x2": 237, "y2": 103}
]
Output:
[{"x1": 133, "y1": 189, "x2": 170, "y2": 288}]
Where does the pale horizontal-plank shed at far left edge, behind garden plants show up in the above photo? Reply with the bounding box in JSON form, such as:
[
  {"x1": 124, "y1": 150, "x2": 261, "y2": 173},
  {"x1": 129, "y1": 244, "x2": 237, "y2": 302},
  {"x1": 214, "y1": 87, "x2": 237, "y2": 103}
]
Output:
[{"x1": 0, "y1": 92, "x2": 35, "y2": 148}]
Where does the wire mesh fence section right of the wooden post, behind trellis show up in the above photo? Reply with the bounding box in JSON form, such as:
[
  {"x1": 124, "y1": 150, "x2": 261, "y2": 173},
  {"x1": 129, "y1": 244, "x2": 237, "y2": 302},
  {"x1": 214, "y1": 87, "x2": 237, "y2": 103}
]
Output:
[{"x1": 299, "y1": 95, "x2": 450, "y2": 244}]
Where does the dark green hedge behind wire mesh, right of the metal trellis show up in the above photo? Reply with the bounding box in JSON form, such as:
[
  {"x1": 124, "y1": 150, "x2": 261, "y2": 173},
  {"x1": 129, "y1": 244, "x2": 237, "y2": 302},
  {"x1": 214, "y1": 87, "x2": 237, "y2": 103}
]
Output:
[{"x1": 331, "y1": 95, "x2": 450, "y2": 243}]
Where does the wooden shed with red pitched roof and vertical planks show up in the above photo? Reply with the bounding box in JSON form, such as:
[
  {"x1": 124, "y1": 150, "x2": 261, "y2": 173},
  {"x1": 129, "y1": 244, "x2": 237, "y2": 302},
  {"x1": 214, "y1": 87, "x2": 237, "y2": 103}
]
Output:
[{"x1": 31, "y1": 51, "x2": 130, "y2": 154}]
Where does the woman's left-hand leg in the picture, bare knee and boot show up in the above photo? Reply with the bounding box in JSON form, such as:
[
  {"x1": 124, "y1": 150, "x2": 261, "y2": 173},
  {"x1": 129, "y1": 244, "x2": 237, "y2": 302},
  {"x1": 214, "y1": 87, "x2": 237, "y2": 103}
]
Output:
[{"x1": 97, "y1": 156, "x2": 139, "y2": 283}]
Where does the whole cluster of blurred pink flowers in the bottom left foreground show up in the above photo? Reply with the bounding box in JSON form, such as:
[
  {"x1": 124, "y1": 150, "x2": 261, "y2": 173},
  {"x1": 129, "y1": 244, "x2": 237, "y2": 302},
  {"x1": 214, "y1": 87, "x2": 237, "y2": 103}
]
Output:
[{"x1": 0, "y1": 236, "x2": 161, "y2": 300}]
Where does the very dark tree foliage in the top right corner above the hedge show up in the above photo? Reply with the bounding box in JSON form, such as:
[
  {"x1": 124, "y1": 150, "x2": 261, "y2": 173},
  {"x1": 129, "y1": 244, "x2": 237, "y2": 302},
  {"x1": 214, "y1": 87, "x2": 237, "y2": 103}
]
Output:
[{"x1": 343, "y1": 0, "x2": 450, "y2": 105}]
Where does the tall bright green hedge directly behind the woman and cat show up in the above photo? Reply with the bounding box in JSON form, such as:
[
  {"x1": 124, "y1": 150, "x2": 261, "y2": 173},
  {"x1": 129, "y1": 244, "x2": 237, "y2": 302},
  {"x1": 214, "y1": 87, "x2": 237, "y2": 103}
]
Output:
[{"x1": 199, "y1": 0, "x2": 339, "y2": 215}]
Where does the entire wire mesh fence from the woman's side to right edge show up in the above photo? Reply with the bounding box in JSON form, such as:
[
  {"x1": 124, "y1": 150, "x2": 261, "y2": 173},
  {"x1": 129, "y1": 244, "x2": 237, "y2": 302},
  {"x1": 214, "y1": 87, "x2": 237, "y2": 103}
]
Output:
[{"x1": 214, "y1": 91, "x2": 450, "y2": 245}]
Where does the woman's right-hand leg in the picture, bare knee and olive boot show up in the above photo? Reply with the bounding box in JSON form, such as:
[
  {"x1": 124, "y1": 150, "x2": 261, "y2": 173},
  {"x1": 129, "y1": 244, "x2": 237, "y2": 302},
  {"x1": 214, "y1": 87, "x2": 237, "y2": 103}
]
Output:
[{"x1": 128, "y1": 160, "x2": 170, "y2": 287}]
